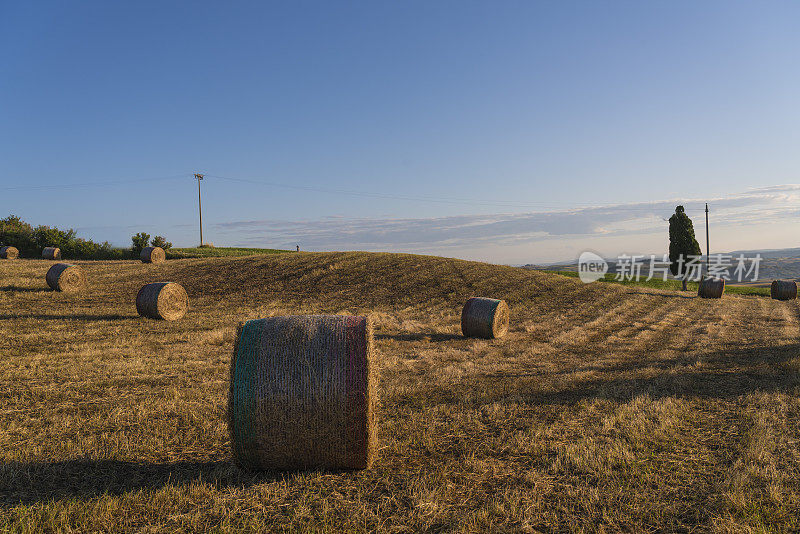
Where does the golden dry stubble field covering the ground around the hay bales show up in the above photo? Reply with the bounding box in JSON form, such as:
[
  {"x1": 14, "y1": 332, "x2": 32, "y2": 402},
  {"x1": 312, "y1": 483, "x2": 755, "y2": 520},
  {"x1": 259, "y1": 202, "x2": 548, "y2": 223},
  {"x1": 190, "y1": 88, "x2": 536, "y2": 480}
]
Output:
[{"x1": 0, "y1": 253, "x2": 800, "y2": 532}]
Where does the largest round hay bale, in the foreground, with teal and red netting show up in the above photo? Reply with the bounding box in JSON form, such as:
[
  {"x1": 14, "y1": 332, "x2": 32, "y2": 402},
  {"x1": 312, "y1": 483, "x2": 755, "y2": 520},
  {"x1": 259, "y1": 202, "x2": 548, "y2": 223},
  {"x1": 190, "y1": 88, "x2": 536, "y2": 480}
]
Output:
[{"x1": 228, "y1": 315, "x2": 377, "y2": 470}]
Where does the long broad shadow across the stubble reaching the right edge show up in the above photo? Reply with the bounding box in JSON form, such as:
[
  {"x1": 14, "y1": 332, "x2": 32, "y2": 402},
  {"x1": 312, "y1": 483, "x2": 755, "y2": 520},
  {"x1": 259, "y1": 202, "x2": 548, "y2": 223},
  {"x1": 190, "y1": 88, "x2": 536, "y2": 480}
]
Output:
[{"x1": 396, "y1": 343, "x2": 800, "y2": 408}]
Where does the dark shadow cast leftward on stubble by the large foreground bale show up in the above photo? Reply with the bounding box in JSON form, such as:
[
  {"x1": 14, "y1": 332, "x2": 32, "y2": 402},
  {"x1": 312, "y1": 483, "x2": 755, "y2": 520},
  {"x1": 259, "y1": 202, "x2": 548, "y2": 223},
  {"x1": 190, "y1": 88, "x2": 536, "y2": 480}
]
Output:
[{"x1": 0, "y1": 460, "x2": 287, "y2": 508}]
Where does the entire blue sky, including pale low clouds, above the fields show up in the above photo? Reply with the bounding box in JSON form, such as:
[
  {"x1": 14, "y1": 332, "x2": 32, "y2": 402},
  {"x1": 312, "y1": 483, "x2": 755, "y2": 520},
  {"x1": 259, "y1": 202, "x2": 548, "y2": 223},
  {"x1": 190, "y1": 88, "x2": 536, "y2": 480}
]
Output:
[{"x1": 0, "y1": 0, "x2": 800, "y2": 263}]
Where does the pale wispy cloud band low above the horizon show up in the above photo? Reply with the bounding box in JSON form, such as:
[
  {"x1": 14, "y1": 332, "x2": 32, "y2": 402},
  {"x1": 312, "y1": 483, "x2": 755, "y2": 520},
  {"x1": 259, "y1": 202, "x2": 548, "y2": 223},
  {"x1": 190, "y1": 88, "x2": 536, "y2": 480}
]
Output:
[{"x1": 216, "y1": 184, "x2": 800, "y2": 258}]
